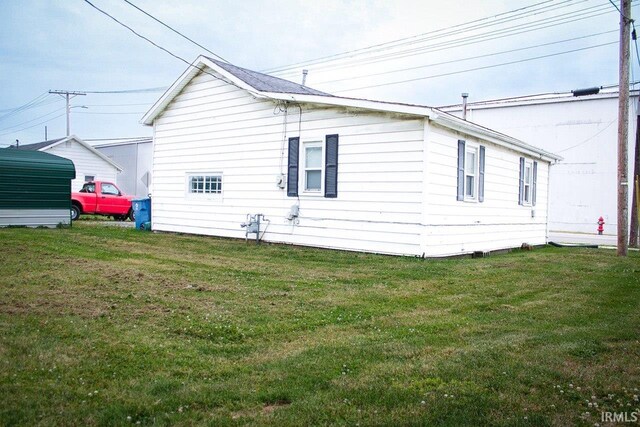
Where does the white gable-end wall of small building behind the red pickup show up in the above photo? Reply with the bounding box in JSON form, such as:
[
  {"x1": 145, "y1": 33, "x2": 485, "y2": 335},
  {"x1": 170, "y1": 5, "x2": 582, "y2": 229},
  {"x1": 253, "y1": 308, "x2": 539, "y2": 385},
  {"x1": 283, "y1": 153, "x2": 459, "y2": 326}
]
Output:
[{"x1": 43, "y1": 139, "x2": 118, "y2": 191}]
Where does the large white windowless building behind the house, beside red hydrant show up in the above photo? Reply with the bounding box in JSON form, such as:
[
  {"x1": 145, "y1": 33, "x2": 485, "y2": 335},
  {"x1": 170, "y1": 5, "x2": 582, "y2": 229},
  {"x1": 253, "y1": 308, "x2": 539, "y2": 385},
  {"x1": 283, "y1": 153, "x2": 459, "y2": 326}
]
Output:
[{"x1": 442, "y1": 87, "x2": 638, "y2": 244}]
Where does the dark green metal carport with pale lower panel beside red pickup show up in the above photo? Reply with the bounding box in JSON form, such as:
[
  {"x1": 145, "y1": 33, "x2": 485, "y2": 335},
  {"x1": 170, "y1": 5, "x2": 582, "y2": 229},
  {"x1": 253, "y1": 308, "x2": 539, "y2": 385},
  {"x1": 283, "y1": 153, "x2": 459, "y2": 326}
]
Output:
[{"x1": 0, "y1": 148, "x2": 76, "y2": 227}]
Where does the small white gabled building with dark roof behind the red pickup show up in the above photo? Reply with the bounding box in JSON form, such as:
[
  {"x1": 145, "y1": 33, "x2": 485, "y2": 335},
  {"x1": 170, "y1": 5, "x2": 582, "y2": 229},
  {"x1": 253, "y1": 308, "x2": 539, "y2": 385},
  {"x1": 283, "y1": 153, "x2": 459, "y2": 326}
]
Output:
[{"x1": 17, "y1": 135, "x2": 122, "y2": 191}]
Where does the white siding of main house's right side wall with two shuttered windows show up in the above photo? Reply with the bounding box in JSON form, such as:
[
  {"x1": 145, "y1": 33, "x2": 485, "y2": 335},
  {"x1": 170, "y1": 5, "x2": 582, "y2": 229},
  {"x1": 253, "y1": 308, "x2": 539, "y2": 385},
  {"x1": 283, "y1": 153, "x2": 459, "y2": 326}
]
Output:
[{"x1": 424, "y1": 125, "x2": 549, "y2": 256}]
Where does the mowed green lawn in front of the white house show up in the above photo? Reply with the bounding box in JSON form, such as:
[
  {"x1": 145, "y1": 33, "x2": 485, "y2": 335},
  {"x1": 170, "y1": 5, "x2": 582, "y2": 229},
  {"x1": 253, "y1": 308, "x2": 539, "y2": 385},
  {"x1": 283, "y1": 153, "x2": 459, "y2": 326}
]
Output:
[{"x1": 0, "y1": 223, "x2": 640, "y2": 426}]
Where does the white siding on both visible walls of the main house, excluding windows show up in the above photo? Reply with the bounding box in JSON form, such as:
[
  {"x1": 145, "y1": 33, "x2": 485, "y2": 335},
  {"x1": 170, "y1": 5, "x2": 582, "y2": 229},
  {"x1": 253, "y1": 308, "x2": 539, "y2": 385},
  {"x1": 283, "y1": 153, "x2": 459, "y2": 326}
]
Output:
[{"x1": 152, "y1": 69, "x2": 548, "y2": 256}]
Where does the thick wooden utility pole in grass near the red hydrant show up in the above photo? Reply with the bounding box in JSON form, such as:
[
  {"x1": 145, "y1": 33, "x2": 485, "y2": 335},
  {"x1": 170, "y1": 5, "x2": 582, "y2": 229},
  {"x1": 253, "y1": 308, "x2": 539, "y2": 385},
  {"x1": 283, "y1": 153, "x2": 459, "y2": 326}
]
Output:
[{"x1": 618, "y1": 0, "x2": 631, "y2": 256}]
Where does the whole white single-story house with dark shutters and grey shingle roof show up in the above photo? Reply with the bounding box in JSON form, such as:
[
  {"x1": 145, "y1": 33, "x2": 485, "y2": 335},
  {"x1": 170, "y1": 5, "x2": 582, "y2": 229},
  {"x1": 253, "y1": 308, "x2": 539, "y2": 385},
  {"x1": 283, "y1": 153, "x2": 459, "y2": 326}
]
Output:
[{"x1": 142, "y1": 56, "x2": 559, "y2": 256}]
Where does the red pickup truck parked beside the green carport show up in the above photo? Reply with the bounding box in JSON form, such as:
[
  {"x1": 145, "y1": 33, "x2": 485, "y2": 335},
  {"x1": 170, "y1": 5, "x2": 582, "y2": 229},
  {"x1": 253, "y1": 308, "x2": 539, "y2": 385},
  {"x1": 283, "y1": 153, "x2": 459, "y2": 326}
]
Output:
[{"x1": 71, "y1": 181, "x2": 134, "y2": 221}]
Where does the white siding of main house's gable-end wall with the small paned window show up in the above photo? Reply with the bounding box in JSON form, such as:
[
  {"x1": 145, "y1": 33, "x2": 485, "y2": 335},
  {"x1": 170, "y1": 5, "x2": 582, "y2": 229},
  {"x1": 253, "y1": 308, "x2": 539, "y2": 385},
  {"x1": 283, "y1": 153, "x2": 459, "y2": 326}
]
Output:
[{"x1": 152, "y1": 74, "x2": 424, "y2": 255}]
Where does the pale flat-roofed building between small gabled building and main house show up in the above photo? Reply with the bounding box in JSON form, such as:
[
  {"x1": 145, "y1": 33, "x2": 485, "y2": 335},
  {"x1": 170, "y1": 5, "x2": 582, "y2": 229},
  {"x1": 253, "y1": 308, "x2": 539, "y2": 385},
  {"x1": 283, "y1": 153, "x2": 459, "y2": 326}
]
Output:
[{"x1": 92, "y1": 138, "x2": 153, "y2": 197}]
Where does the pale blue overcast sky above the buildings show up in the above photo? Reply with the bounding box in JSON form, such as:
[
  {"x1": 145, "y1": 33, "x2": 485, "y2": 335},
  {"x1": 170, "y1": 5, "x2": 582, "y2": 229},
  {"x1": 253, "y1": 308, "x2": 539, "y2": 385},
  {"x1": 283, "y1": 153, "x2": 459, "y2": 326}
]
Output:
[{"x1": 0, "y1": 0, "x2": 640, "y2": 146}]
